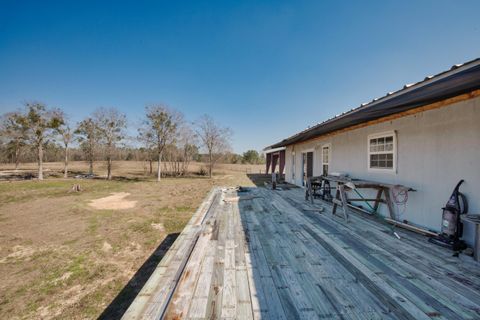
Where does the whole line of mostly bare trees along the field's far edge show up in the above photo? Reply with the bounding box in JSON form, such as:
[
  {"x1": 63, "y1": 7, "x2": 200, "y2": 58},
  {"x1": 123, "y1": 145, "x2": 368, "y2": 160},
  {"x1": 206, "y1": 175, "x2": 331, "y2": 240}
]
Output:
[{"x1": 0, "y1": 102, "x2": 264, "y2": 181}]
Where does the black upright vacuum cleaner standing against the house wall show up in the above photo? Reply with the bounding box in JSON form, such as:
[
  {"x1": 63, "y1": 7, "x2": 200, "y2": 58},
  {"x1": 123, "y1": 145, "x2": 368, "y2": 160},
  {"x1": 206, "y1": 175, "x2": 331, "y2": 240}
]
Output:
[{"x1": 428, "y1": 180, "x2": 468, "y2": 251}]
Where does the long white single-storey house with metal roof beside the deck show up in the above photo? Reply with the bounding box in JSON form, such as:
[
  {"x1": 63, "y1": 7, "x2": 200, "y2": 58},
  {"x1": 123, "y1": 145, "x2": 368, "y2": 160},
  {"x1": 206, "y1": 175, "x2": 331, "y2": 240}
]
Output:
[{"x1": 266, "y1": 59, "x2": 480, "y2": 244}]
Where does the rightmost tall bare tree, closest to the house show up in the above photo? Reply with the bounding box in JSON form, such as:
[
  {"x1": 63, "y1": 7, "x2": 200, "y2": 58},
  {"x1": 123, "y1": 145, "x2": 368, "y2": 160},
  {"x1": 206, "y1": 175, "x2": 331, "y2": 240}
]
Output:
[{"x1": 197, "y1": 115, "x2": 232, "y2": 177}]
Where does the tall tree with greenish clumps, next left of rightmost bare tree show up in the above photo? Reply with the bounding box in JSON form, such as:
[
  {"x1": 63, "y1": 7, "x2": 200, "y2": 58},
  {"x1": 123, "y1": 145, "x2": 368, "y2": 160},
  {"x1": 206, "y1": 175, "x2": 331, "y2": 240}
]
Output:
[{"x1": 144, "y1": 105, "x2": 183, "y2": 181}]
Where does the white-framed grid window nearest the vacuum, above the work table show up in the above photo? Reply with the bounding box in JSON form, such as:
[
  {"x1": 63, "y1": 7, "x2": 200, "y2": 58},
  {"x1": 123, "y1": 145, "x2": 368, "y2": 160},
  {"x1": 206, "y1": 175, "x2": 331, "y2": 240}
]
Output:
[{"x1": 368, "y1": 132, "x2": 397, "y2": 172}]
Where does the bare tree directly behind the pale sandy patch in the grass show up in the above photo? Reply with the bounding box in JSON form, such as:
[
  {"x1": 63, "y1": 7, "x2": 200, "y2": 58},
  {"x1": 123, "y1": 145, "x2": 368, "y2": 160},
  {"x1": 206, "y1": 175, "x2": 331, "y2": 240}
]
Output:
[{"x1": 94, "y1": 108, "x2": 127, "y2": 180}]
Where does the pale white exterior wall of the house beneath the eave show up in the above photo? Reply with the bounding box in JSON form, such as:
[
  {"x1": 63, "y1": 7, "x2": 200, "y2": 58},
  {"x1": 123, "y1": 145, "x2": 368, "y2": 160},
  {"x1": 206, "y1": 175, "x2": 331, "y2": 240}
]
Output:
[{"x1": 285, "y1": 98, "x2": 480, "y2": 244}]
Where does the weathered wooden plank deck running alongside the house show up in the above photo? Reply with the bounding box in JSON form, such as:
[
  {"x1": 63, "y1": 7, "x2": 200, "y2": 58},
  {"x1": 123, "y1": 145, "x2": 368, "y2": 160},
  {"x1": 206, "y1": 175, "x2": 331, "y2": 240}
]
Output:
[{"x1": 124, "y1": 188, "x2": 480, "y2": 319}]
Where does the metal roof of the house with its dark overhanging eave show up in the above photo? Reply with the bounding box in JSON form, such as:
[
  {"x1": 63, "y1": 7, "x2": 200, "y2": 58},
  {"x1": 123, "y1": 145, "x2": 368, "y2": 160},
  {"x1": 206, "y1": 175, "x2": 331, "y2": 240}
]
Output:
[{"x1": 265, "y1": 58, "x2": 480, "y2": 150}]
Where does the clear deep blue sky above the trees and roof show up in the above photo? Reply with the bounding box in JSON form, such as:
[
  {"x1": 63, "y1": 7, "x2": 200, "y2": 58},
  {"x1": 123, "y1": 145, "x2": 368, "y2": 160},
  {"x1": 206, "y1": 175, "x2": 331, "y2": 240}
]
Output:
[{"x1": 0, "y1": 0, "x2": 480, "y2": 152}]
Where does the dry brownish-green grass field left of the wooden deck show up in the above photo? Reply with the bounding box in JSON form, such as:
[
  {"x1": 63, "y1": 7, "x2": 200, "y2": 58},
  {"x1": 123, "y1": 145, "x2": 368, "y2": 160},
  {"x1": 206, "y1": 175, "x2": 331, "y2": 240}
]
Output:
[{"x1": 0, "y1": 162, "x2": 263, "y2": 319}]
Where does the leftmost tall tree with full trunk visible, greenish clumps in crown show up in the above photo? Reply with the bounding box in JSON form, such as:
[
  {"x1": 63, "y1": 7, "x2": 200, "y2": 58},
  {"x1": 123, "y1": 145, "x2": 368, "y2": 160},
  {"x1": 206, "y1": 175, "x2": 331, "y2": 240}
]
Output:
[{"x1": 18, "y1": 102, "x2": 63, "y2": 180}]
